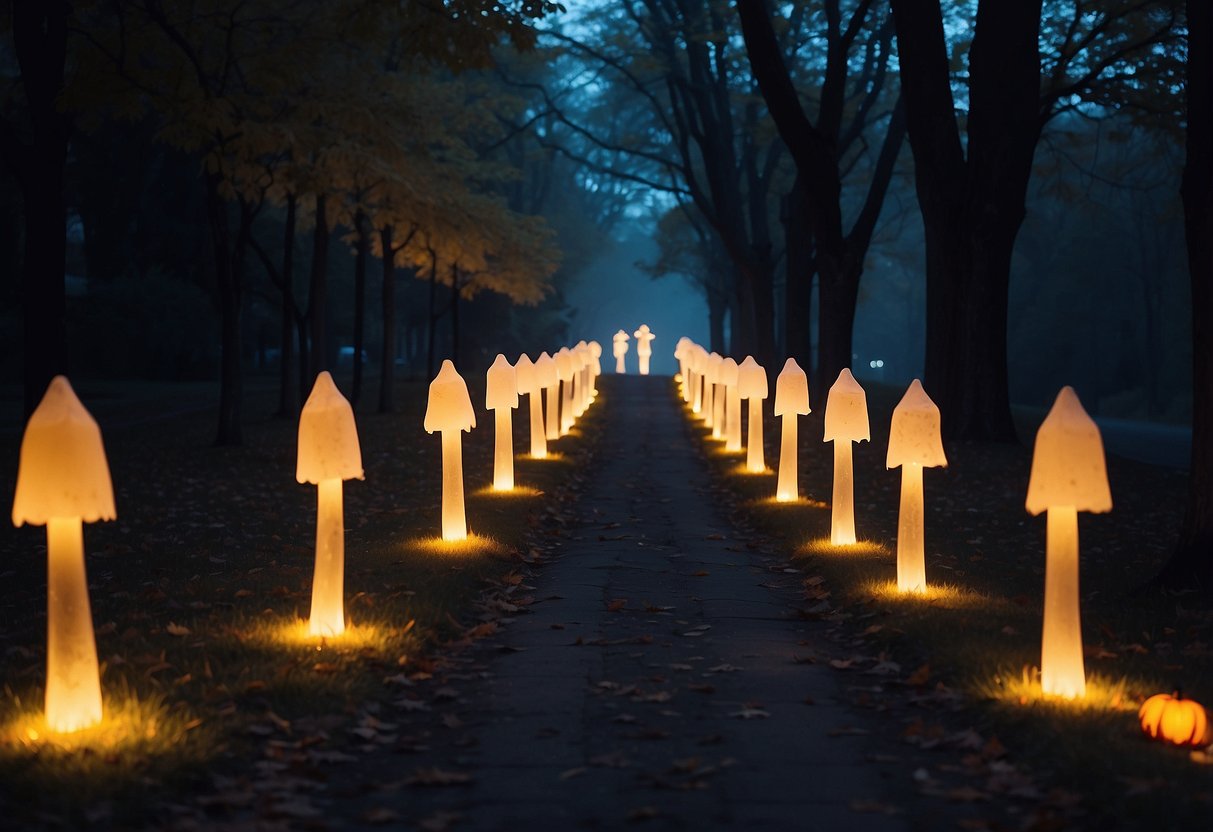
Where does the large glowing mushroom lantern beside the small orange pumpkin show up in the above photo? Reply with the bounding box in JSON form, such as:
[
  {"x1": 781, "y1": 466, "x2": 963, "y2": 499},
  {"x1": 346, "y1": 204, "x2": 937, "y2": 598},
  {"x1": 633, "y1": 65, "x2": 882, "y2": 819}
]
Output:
[{"x1": 1026, "y1": 387, "x2": 1112, "y2": 699}]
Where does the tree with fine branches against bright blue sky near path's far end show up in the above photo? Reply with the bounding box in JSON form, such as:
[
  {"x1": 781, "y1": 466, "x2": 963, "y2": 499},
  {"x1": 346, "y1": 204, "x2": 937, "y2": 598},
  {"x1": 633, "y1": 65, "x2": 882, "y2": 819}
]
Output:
[{"x1": 516, "y1": 0, "x2": 786, "y2": 363}]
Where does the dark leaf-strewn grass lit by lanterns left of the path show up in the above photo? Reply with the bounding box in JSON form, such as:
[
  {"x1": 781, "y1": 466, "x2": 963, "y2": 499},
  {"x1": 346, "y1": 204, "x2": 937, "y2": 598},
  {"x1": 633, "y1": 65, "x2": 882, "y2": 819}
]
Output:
[{"x1": 0, "y1": 377, "x2": 600, "y2": 827}]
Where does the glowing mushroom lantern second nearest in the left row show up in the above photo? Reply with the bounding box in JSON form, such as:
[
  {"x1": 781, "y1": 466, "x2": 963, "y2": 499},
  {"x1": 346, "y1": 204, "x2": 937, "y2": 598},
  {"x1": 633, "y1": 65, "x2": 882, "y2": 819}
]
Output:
[{"x1": 295, "y1": 371, "x2": 363, "y2": 636}]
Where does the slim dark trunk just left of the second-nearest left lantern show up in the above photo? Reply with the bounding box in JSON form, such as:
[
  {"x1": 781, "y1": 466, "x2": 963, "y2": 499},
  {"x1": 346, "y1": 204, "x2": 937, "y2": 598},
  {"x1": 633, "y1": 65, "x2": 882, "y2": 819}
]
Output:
[{"x1": 206, "y1": 173, "x2": 244, "y2": 445}]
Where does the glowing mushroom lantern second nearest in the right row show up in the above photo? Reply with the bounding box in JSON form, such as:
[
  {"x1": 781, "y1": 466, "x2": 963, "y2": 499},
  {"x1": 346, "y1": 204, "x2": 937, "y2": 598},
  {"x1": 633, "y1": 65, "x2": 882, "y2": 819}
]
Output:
[{"x1": 885, "y1": 378, "x2": 947, "y2": 593}]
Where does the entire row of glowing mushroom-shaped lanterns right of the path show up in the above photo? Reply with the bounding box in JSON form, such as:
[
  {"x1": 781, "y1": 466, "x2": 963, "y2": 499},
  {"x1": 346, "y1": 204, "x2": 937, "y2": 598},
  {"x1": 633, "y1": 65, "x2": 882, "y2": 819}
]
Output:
[{"x1": 674, "y1": 338, "x2": 1112, "y2": 699}]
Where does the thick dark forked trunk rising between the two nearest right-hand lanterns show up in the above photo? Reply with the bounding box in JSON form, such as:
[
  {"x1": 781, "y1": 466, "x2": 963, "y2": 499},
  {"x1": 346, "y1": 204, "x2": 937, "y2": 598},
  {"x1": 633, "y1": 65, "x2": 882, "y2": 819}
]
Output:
[{"x1": 892, "y1": 0, "x2": 1041, "y2": 441}]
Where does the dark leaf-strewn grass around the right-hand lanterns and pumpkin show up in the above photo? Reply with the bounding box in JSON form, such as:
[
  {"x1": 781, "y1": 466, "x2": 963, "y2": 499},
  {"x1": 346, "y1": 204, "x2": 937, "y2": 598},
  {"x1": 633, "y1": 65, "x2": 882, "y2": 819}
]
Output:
[{"x1": 688, "y1": 386, "x2": 1213, "y2": 830}]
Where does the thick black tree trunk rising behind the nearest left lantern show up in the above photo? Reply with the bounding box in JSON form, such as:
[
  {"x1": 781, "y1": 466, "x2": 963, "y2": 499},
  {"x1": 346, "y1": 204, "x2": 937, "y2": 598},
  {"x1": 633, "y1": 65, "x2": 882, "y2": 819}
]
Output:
[{"x1": 4, "y1": 0, "x2": 72, "y2": 416}]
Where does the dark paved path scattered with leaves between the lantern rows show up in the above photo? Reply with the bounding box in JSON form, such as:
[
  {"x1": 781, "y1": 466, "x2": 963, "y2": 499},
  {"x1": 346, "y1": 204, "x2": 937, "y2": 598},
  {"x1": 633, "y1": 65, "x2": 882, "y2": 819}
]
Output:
[{"x1": 363, "y1": 377, "x2": 906, "y2": 830}]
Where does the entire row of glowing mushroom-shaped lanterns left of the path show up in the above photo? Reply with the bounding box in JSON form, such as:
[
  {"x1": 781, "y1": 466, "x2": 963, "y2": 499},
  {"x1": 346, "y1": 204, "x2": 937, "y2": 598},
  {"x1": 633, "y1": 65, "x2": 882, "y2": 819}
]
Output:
[{"x1": 12, "y1": 341, "x2": 602, "y2": 733}]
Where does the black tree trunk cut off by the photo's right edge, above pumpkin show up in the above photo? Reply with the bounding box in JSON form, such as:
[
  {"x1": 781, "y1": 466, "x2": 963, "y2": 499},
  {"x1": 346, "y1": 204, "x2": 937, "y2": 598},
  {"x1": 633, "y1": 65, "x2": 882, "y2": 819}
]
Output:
[{"x1": 1158, "y1": 0, "x2": 1213, "y2": 598}]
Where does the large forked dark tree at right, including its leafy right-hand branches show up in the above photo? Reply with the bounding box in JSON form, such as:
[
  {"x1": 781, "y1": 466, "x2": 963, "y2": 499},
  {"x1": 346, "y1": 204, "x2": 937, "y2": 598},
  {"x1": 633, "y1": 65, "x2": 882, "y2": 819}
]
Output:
[{"x1": 890, "y1": 0, "x2": 1174, "y2": 441}]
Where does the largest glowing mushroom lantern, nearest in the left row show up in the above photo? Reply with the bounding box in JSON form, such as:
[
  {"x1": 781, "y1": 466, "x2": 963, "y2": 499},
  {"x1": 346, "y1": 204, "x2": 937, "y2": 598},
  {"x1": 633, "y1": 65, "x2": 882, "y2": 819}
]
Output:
[{"x1": 12, "y1": 376, "x2": 116, "y2": 733}]
